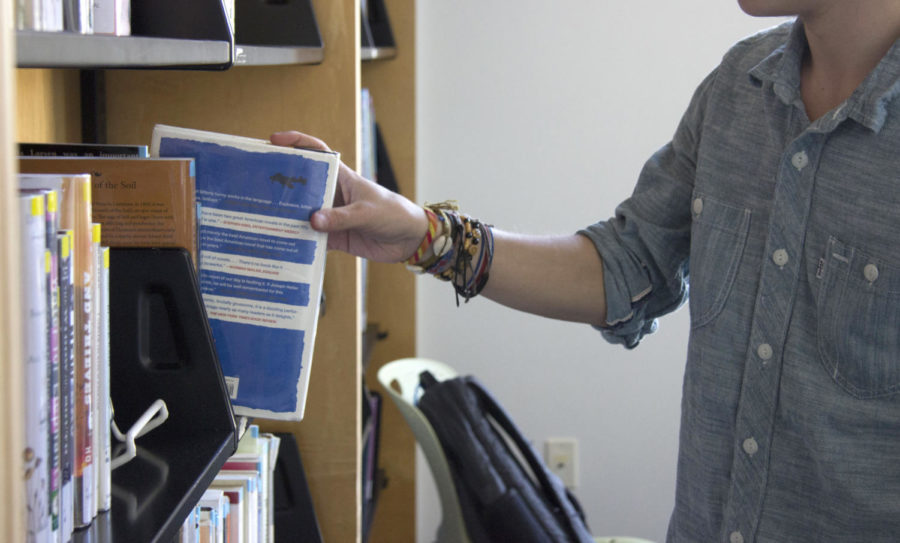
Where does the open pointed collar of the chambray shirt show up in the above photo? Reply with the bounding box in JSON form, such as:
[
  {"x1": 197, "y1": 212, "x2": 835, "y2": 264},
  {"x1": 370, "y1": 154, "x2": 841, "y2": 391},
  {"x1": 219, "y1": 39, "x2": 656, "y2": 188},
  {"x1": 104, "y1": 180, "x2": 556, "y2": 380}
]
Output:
[{"x1": 749, "y1": 21, "x2": 900, "y2": 133}]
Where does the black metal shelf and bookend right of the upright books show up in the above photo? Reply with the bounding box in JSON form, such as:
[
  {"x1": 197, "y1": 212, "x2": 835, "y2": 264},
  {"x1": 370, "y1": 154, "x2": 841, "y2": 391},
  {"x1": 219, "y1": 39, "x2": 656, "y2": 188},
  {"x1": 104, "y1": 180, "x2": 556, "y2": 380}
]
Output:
[{"x1": 109, "y1": 248, "x2": 238, "y2": 543}]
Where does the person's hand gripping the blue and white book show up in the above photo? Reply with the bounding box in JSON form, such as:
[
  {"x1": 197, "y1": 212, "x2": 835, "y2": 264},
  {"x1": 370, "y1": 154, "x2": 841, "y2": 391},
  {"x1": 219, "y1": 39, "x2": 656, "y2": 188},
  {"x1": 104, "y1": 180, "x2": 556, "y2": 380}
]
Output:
[{"x1": 270, "y1": 131, "x2": 428, "y2": 262}]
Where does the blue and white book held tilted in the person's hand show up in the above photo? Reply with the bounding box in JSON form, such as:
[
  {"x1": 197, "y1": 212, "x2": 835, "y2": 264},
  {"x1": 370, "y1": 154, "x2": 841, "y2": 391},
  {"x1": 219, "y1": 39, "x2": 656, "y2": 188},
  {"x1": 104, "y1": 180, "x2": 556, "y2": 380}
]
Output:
[{"x1": 150, "y1": 125, "x2": 340, "y2": 420}]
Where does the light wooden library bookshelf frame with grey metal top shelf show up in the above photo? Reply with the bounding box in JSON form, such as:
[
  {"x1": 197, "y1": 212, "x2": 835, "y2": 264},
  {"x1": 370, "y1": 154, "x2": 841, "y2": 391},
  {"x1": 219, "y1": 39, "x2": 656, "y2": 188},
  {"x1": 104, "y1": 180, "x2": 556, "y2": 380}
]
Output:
[{"x1": 0, "y1": 0, "x2": 415, "y2": 542}]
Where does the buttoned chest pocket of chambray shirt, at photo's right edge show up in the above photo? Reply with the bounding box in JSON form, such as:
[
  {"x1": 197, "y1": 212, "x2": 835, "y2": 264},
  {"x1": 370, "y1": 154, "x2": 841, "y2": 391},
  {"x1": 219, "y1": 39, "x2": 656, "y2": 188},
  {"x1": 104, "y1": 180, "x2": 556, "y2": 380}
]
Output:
[{"x1": 816, "y1": 237, "x2": 900, "y2": 399}]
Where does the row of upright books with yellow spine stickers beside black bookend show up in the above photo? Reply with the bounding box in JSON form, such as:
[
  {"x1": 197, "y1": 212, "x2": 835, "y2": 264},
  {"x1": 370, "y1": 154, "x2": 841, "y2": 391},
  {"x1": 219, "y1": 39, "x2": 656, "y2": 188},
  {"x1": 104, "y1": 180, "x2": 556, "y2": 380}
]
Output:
[{"x1": 19, "y1": 167, "x2": 111, "y2": 541}]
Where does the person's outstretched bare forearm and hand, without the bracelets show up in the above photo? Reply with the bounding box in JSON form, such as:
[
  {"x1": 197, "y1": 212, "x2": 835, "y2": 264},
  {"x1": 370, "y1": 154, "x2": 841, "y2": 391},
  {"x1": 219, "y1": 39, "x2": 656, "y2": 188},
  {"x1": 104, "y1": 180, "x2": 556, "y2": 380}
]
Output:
[{"x1": 272, "y1": 132, "x2": 606, "y2": 324}]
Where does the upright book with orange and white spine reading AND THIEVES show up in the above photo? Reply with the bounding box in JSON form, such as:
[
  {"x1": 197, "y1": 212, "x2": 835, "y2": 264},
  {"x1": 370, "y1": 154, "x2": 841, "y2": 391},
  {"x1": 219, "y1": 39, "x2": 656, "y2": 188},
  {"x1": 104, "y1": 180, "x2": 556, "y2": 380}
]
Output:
[{"x1": 19, "y1": 173, "x2": 96, "y2": 527}]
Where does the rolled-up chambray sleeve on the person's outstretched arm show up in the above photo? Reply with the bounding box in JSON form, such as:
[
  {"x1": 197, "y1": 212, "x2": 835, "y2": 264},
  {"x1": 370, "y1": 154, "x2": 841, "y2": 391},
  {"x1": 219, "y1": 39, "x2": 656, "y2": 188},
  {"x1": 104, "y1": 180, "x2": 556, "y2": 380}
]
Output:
[{"x1": 578, "y1": 71, "x2": 716, "y2": 349}]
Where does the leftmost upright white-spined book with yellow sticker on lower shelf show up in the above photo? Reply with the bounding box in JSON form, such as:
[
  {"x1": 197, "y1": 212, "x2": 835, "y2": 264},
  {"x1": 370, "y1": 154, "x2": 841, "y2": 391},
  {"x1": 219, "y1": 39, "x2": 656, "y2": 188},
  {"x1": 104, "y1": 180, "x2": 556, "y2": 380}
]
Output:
[{"x1": 19, "y1": 193, "x2": 51, "y2": 541}]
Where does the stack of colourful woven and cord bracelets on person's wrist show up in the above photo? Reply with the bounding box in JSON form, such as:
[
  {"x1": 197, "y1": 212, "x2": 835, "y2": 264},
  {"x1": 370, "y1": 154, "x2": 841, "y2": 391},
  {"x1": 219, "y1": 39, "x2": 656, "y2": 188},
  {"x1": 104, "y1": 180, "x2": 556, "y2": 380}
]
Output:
[{"x1": 406, "y1": 202, "x2": 494, "y2": 305}]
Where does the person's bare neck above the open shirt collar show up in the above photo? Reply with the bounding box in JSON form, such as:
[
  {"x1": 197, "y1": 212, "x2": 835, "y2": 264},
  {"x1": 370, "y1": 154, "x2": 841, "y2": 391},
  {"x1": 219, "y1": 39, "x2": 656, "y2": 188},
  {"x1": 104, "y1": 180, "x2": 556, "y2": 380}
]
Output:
[{"x1": 800, "y1": 0, "x2": 900, "y2": 120}]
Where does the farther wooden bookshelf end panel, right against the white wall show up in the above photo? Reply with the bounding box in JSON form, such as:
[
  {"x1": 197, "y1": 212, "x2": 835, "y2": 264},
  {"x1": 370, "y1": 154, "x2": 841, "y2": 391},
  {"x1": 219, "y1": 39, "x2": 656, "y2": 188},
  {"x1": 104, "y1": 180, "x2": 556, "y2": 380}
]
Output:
[{"x1": 362, "y1": 0, "x2": 417, "y2": 543}]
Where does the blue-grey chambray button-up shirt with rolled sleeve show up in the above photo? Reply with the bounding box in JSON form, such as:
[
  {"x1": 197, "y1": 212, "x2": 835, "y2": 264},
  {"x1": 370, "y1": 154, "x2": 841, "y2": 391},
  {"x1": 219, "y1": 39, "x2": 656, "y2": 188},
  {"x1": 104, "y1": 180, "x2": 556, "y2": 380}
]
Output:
[{"x1": 581, "y1": 22, "x2": 900, "y2": 543}]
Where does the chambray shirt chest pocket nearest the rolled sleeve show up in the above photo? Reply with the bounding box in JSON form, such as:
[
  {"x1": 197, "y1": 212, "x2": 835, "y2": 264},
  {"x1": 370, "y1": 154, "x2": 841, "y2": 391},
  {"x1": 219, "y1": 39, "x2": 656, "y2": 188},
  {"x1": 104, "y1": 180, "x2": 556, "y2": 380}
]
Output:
[{"x1": 688, "y1": 192, "x2": 750, "y2": 328}]
